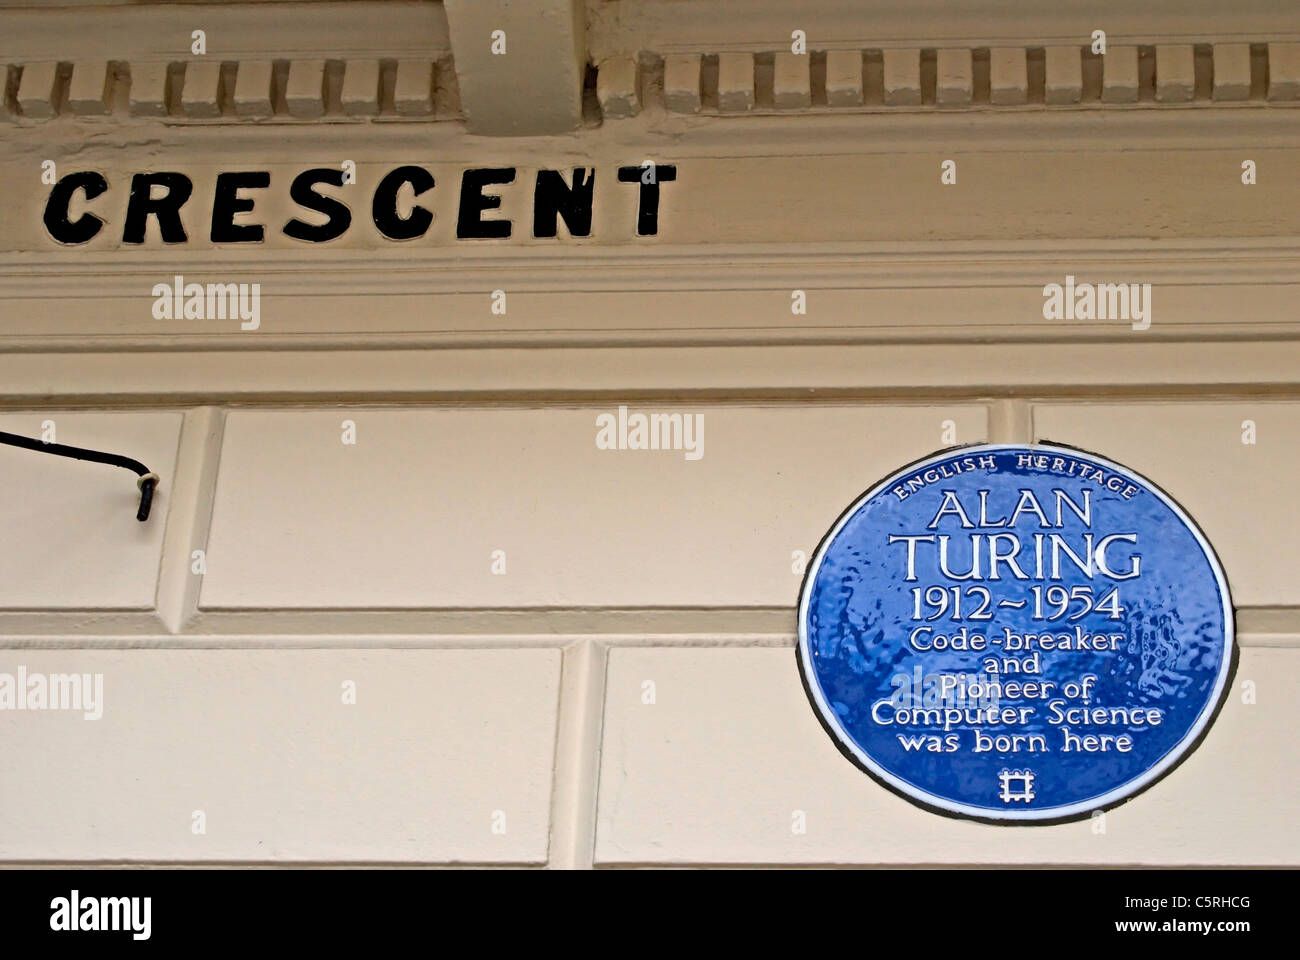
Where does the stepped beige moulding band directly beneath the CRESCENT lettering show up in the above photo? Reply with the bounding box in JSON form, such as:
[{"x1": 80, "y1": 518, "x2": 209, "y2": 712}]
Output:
[{"x1": 0, "y1": 239, "x2": 1300, "y2": 354}]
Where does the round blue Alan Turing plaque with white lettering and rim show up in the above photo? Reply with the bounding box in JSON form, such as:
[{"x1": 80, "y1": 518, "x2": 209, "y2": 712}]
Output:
[{"x1": 798, "y1": 444, "x2": 1235, "y2": 823}]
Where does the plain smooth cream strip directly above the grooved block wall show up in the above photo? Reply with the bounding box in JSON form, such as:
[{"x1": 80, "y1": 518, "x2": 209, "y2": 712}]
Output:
[{"x1": 0, "y1": 334, "x2": 1300, "y2": 410}]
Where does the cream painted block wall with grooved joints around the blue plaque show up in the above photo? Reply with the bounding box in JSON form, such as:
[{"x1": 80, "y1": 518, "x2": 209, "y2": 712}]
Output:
[{"x1": 0, "y1": 398, "x2": 1300, "y2": 865}]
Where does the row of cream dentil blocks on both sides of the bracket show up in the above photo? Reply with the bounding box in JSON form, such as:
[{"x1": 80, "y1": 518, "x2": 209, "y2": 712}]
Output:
[{"x1": 0, "y1": 42, "x2": 1300, "y2": 124}]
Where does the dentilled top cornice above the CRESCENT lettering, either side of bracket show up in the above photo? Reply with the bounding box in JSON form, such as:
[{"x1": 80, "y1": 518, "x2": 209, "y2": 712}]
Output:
[{"x1": 0, "y1": 0, "x2": 1300, "y2": 133}]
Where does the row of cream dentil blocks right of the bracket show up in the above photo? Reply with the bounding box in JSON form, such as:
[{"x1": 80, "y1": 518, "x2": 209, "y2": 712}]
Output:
[{"x1": 595, "y1": 42, "x2": 1300, "y2": 120}]
